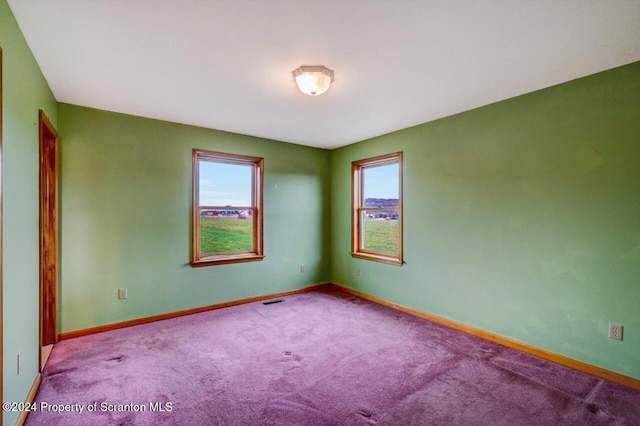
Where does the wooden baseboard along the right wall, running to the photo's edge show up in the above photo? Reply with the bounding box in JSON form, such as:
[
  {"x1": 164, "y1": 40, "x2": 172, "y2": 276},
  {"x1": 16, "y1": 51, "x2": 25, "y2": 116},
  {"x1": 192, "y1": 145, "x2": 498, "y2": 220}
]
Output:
[{"x1": 329, "y1": 283, "x2": 640, "y2": 390}]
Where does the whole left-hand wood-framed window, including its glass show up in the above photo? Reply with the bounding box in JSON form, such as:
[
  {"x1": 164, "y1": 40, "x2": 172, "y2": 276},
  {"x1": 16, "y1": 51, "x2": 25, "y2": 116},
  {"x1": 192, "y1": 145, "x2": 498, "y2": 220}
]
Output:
[{"x1": 191, "y1": 149, "x2": 264, "y2": 266}]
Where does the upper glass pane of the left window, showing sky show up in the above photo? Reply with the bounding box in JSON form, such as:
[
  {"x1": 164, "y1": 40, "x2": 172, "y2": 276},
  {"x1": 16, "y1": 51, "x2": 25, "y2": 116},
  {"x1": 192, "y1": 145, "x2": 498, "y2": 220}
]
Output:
[{"x1": 198, "y1": 160, "x2": 252, "y2": 207}]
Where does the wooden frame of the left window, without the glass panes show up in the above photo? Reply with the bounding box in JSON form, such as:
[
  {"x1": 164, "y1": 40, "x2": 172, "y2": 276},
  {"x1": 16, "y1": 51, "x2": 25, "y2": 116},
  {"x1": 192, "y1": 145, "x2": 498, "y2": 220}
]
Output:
[{"x1": 191, "y1": 149, "x2": 265, "y2": 267}]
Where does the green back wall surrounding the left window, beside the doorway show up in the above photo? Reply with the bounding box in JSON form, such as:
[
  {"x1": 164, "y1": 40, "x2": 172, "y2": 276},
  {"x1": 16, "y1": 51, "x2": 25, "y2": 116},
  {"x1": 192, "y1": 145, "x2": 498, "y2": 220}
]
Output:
[{"x1": 58, "y1": 104, "x2": 330, "y2": 332}]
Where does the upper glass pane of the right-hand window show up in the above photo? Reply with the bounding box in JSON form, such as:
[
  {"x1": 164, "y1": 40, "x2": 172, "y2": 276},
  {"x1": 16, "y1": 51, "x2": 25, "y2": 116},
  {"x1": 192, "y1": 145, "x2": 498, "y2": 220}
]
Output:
[{"x1": 362, "y1": 163, "x2": 400, "y2": 207}]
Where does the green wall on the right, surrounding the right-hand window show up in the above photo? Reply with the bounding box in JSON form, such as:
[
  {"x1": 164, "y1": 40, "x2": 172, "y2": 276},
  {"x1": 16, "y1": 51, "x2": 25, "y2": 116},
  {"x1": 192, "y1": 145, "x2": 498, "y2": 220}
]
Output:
[{"x1": 331, "y1": 62, "x2": 640, "y2": 379}]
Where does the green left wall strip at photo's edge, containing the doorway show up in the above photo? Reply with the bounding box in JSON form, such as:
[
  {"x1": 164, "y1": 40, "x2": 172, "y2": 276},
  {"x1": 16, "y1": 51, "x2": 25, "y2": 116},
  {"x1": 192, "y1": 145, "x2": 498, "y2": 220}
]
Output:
[{"x1": 0, "y1": 0, "x2": 57, "y2": 424}]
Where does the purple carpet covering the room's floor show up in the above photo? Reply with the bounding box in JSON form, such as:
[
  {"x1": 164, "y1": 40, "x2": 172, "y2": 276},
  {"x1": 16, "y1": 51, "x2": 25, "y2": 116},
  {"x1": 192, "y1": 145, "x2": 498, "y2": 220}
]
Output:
[{"x1": 27, "y1": 290, "x2": 640, "y2": 426}]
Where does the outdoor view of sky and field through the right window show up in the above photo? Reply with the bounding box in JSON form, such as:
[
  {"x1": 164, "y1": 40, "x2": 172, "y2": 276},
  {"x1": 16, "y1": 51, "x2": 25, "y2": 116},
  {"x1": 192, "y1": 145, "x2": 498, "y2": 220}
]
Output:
[{"x1": 360, "y1": 163, "x2": 400, "y2": 254}]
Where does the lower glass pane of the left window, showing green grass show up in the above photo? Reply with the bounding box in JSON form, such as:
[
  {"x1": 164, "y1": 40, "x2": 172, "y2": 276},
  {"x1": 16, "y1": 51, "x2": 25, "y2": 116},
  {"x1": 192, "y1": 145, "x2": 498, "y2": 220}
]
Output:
[{"x1": 200, "y1": 209, "x2": 253, "y2": 255}]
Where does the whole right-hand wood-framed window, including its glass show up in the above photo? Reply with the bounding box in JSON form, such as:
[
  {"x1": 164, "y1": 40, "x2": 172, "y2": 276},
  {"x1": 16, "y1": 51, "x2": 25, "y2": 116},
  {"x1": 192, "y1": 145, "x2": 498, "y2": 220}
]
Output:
[{"x1": 351, "y1": 152, "x2": 403, "y2": 265}]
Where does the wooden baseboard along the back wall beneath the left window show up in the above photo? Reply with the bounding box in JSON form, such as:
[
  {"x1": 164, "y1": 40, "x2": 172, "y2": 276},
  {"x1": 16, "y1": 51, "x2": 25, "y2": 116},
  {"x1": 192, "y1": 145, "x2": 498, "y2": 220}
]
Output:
[{"x1": 59, "y1": 284, "x2": 330, "y2": 340}]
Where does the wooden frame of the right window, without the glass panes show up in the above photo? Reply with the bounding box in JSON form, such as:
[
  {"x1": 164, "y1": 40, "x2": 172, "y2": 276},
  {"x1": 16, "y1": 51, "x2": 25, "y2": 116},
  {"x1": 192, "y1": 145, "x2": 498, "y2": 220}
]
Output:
[{"x1": 351, "y1": 152, "x2": 404, "y2": 266}]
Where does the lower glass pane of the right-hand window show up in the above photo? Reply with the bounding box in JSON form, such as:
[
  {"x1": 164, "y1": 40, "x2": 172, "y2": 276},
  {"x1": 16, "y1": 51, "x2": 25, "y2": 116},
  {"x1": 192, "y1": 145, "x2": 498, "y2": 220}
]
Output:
[{"x1": 360, "y1": 210, "x2": 399, "y2": 253}]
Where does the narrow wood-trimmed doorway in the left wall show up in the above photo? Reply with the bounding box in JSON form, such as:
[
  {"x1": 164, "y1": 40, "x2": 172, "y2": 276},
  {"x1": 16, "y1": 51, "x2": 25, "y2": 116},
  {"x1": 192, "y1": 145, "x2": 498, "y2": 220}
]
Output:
[{"x1": 39, "y1": 110, "x2": 58, "y2": 370}]
